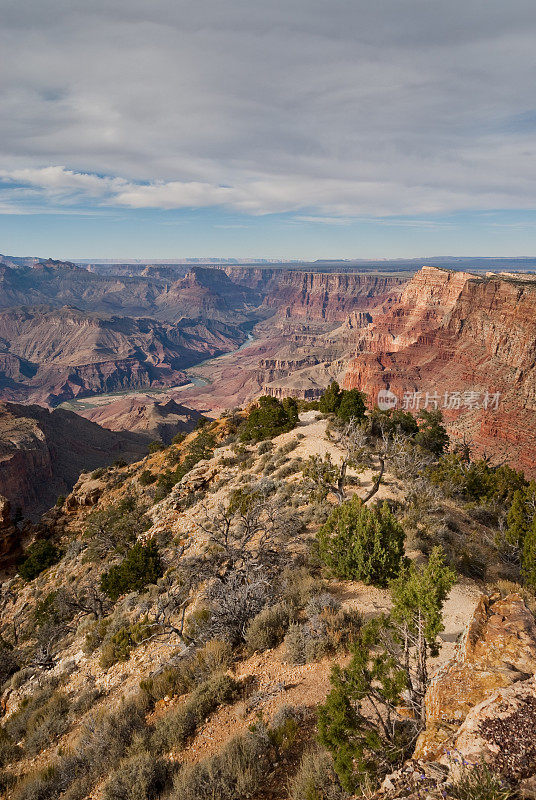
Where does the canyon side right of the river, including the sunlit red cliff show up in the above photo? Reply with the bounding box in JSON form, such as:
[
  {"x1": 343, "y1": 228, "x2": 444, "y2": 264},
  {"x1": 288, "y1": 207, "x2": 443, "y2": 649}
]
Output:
[{"x1": 162, "y1": 266, "x2": 536, "y2": 476}]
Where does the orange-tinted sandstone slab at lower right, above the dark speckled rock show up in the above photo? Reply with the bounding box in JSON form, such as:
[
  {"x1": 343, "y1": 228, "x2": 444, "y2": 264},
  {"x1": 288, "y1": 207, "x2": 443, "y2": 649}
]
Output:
[{"x1": 415, "y1": 594, "x2": 536, "y2": 758}]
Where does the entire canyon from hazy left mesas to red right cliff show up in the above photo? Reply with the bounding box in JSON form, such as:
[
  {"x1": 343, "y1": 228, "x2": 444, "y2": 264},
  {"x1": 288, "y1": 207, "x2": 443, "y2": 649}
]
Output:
[{"x1": 0, "y1": 258, "x2": 536, "y2": 520}]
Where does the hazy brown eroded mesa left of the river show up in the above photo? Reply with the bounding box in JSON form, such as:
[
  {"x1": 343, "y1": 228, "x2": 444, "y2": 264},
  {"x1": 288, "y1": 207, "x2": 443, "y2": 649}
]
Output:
[{"x1": 0, "y1": 307, "x2": 245, "y2": 405}]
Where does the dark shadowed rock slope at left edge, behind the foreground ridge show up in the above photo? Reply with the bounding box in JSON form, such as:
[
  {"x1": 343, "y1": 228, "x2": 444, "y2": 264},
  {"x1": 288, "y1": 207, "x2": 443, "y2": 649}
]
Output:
[{"x1": 0, "y1": 403, "x2": 149, "y2": 517}]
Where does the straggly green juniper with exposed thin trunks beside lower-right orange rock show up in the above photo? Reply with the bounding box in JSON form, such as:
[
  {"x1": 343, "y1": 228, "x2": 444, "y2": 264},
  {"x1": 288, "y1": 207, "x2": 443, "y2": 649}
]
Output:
[{"x1": 318, "y1": 548, "x2": 455, "y2": 792}]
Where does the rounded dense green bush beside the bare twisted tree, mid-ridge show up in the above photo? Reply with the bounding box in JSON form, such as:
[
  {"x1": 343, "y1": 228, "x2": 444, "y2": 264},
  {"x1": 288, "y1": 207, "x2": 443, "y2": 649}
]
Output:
[{"x1": 318, "y1": 495, "x2": 404, "y2": 586}]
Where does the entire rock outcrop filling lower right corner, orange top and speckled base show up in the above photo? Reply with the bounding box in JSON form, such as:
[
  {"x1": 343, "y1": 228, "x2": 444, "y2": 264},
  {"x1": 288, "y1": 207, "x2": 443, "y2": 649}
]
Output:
[{"x1": 382, "y1": 594, "x2": 536, "y2": 800}]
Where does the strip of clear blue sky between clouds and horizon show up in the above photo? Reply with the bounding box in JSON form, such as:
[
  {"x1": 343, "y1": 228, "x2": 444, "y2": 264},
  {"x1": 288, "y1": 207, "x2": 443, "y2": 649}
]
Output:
[{"x1": 0, "y1": 209, "x2": 536, "y2": 260}]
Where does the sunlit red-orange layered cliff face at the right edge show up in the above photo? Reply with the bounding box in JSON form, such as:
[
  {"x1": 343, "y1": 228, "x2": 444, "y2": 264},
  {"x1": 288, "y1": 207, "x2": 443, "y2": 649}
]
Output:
[{"x1": 344, "y1": 267, "x2": 536, "y2": 474}]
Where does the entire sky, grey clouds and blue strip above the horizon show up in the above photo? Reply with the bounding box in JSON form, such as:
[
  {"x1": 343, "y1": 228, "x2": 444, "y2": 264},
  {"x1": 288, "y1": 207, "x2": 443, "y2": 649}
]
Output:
[{"x1": 0, "y1": 0, "x2": 536, "y2": 260}]
